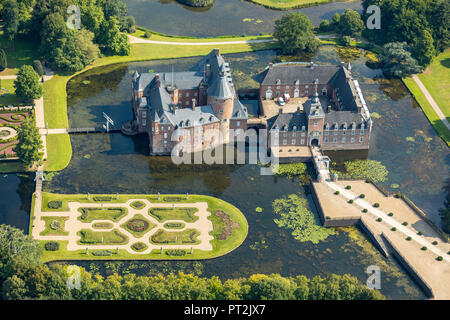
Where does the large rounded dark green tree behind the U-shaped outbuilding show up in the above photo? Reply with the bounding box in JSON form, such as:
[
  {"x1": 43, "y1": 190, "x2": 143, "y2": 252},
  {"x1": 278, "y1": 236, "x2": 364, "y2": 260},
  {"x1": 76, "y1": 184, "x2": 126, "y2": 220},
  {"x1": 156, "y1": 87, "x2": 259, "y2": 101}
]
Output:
[{"x1": 273, "y1": 12, "x2": 319, "y2": 54}]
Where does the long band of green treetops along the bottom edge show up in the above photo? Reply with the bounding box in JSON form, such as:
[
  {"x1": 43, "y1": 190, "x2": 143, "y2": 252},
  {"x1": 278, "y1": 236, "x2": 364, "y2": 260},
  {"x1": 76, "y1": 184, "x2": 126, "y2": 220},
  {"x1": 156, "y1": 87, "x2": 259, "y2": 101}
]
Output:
[{"x1": 0, "y1": 225, "x2": 384, "y2": 300}]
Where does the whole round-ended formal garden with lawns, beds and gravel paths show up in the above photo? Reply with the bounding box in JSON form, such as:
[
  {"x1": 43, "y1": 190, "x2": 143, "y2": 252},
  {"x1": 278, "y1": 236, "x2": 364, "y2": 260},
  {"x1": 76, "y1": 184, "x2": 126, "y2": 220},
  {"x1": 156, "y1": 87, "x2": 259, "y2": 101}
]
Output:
[{"x1": 30, "y1": 192, "x2": 248, "y2": 261}]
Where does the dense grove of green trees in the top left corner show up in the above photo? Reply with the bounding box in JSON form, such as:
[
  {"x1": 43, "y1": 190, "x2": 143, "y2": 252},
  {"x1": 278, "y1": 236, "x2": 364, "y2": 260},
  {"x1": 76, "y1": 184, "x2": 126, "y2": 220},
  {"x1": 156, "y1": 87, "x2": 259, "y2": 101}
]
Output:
[{"x1": 1, "y1": 0, "x2": 135, "y2": 71}]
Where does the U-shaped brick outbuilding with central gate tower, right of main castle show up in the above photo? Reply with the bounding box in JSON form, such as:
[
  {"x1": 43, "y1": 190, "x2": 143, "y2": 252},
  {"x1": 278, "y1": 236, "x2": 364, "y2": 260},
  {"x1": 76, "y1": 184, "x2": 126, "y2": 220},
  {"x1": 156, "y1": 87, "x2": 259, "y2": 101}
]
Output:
[{"x1": 259, "y1": 63, "x2": 372, "y2": 150}]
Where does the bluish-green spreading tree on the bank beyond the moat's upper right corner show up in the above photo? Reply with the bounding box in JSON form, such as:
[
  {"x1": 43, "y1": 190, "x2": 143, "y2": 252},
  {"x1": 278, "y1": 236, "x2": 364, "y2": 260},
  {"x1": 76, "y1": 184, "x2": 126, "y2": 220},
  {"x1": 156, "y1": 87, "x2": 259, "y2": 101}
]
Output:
[{"x1": 380, "y1": 42, "x2": 422, "y2": 78}]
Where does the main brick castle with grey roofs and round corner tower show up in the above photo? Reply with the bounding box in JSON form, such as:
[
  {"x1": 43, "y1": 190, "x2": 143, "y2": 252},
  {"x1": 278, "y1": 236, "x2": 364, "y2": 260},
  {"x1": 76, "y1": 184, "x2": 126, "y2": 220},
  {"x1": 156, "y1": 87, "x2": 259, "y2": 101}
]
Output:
[{"x1": 132, "y1": 49, "x2": 248, "y2": 155}]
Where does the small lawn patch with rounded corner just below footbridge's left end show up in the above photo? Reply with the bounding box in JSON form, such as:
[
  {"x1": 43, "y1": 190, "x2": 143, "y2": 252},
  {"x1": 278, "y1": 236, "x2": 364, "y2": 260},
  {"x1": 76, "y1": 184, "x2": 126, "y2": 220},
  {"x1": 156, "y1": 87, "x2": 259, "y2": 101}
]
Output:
[{"x1": 44, "y1": 134, "x2": 72, "y2": 171}]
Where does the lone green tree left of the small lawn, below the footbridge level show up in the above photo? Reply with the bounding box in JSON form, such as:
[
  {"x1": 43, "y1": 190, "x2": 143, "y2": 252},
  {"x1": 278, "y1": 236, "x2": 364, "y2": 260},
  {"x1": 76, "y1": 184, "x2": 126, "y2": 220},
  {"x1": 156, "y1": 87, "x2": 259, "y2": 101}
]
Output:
[{"x1": 14, "y1": 117, "x2": 43, "y2": 167}]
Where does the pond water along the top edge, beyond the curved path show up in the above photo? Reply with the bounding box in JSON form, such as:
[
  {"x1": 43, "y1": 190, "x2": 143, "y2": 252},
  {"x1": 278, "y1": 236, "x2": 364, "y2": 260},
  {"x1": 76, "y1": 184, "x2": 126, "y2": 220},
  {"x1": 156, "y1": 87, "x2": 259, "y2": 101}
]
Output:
[{"x1": 125, "y1": 0, "x2": 361, "y2": 37}]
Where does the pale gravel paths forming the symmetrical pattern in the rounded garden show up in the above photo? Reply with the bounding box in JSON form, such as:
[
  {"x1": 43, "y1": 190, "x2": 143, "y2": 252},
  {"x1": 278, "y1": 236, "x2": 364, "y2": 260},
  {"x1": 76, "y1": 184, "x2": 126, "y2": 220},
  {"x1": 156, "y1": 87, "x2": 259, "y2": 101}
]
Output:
[{"x1": 32, "y1": 199, "x2": 214, "y2": 255}]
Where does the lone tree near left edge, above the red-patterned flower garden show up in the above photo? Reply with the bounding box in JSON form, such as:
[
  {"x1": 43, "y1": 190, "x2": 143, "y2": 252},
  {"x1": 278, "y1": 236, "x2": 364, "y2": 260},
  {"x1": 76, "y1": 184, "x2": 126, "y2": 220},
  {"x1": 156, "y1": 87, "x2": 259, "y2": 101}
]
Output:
[{"x1": 14, "y1": 65, "x2": 42, "y2": 100}]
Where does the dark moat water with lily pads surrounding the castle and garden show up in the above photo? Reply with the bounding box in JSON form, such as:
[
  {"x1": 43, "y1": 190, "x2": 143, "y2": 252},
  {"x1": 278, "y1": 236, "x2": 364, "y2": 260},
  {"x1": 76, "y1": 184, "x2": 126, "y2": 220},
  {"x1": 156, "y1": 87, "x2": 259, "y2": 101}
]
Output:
[{"x1": 0, "y1": 46, "x2": 450, "y2": 299}]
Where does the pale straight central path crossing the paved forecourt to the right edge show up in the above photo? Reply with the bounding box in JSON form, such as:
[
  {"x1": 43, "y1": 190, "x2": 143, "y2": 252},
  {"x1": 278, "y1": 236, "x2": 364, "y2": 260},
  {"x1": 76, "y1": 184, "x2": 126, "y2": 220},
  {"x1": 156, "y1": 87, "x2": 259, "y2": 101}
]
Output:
[{"x1": 324, "y1": 181, "x2": 450, "y2": 262}]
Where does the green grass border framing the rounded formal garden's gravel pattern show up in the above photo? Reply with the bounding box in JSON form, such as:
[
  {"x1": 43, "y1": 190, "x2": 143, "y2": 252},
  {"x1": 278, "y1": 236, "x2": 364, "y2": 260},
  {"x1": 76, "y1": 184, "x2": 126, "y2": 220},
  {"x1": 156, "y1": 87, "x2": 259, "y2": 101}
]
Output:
[{"x1": 37, "y1": 192, "x2": 248, "y2": 262}]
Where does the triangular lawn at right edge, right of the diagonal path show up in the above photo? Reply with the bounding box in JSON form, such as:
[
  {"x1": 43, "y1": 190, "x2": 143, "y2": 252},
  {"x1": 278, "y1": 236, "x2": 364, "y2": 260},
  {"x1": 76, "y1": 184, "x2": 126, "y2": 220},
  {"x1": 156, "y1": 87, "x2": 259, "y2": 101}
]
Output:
[{"x1": 418, "y1": 49, "x2": 450, "y2": 119}]
